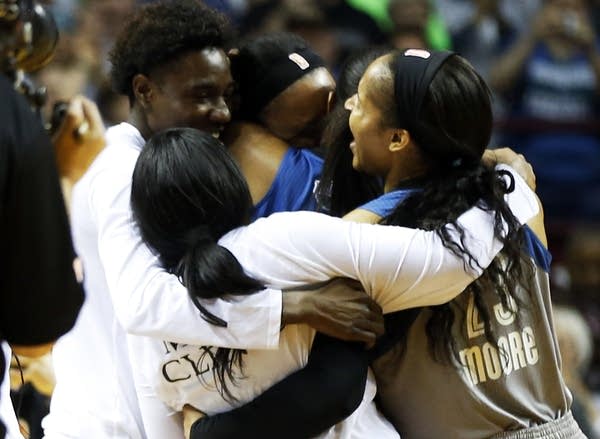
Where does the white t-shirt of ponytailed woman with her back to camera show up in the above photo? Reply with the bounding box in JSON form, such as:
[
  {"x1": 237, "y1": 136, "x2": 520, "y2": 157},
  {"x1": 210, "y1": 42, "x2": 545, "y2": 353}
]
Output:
[{"x1": 130, "y1": 167, "x2": 538, "y2": 438}]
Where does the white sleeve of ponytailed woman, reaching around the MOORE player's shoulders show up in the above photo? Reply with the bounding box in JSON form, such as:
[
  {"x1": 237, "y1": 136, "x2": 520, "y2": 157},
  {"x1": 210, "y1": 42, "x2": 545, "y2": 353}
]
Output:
[{"x1": 238, "y1": 167, "x2": 539, "y2": 313}]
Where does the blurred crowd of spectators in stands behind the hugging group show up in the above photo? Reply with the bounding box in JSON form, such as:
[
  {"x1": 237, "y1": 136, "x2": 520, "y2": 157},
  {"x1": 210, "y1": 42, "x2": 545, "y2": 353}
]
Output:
[{"x1": 10, "y1": 0, "x2": 600, "y2": 437}]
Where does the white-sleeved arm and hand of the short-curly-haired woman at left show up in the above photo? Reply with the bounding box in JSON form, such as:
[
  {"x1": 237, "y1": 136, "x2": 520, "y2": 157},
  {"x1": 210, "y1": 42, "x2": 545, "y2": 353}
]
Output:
[{"x1": 89, "y1": 153, "x2": 376, "y2": 349}]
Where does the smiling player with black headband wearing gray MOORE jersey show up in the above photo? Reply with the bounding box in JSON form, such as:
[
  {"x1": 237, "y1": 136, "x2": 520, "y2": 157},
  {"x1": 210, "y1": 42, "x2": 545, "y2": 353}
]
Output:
[{"x1": 338, "y1": 49, "x2": 585, "y2": 439}]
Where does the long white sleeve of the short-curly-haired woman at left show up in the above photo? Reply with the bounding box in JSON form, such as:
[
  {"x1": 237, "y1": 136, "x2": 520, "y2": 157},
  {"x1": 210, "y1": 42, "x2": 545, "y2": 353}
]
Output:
[{"x1": 88, "y1": 163, "x2": 282, "y2": 348}]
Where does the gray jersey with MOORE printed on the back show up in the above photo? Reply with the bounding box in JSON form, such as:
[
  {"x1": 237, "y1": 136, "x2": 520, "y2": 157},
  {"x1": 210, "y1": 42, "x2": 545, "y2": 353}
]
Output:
[{"x1": 373, "y1": 239, "x2": 572, "y2": 439}]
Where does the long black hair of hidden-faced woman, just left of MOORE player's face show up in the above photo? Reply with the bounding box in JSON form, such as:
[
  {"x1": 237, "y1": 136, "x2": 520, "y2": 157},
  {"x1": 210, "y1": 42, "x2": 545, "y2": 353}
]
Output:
[{"x1": 316, "y1": 46, "x2": 390, "y2": 216}]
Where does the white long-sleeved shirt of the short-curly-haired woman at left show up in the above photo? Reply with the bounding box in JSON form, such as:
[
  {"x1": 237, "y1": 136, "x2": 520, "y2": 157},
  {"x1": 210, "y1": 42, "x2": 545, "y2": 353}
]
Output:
[{"x1": 43, "y1": 123, "x2": 281, "y2": 439}]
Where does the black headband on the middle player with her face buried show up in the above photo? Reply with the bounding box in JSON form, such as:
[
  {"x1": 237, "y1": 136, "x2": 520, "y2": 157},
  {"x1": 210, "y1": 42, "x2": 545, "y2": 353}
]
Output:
[{"x1": 242, "y1": 48, "x2": 325, "y2": 118}]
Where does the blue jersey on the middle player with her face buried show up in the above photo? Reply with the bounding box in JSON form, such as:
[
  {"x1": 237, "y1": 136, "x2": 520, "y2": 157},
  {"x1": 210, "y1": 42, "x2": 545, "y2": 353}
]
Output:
[{"x1": 252, "y1": 147, "x2": 323, "y2": 220}]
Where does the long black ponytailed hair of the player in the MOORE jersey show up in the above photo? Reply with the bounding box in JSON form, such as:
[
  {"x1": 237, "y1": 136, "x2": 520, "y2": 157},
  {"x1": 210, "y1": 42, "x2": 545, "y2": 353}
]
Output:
[{"x1": 382, "y1": 52, "x2": 532, "y2": 362}]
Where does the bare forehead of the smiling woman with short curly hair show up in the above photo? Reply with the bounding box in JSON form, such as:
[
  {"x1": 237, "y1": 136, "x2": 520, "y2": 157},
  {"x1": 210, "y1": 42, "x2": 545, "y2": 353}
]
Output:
[{"x1": 157, "y1": 47, "x2": 233, "y2": 88}]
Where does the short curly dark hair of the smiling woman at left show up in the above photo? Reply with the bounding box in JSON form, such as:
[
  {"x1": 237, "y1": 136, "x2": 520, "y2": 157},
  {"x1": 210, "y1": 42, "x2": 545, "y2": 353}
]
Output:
[{"x1": 109, "y1": 0, "x2": 234, "y2": 102}]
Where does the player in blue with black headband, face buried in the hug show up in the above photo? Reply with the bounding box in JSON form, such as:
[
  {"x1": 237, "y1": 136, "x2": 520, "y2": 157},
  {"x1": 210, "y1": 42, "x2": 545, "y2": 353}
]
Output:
[{"x1": 223, "y1": 33, "x2": 335, "y2": 218}]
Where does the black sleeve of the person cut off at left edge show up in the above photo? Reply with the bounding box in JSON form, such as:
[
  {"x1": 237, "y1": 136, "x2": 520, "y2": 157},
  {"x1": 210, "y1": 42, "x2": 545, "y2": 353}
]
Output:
[{"x1": 0, "y1": 77, "x2": 83, "y2": 345}]
